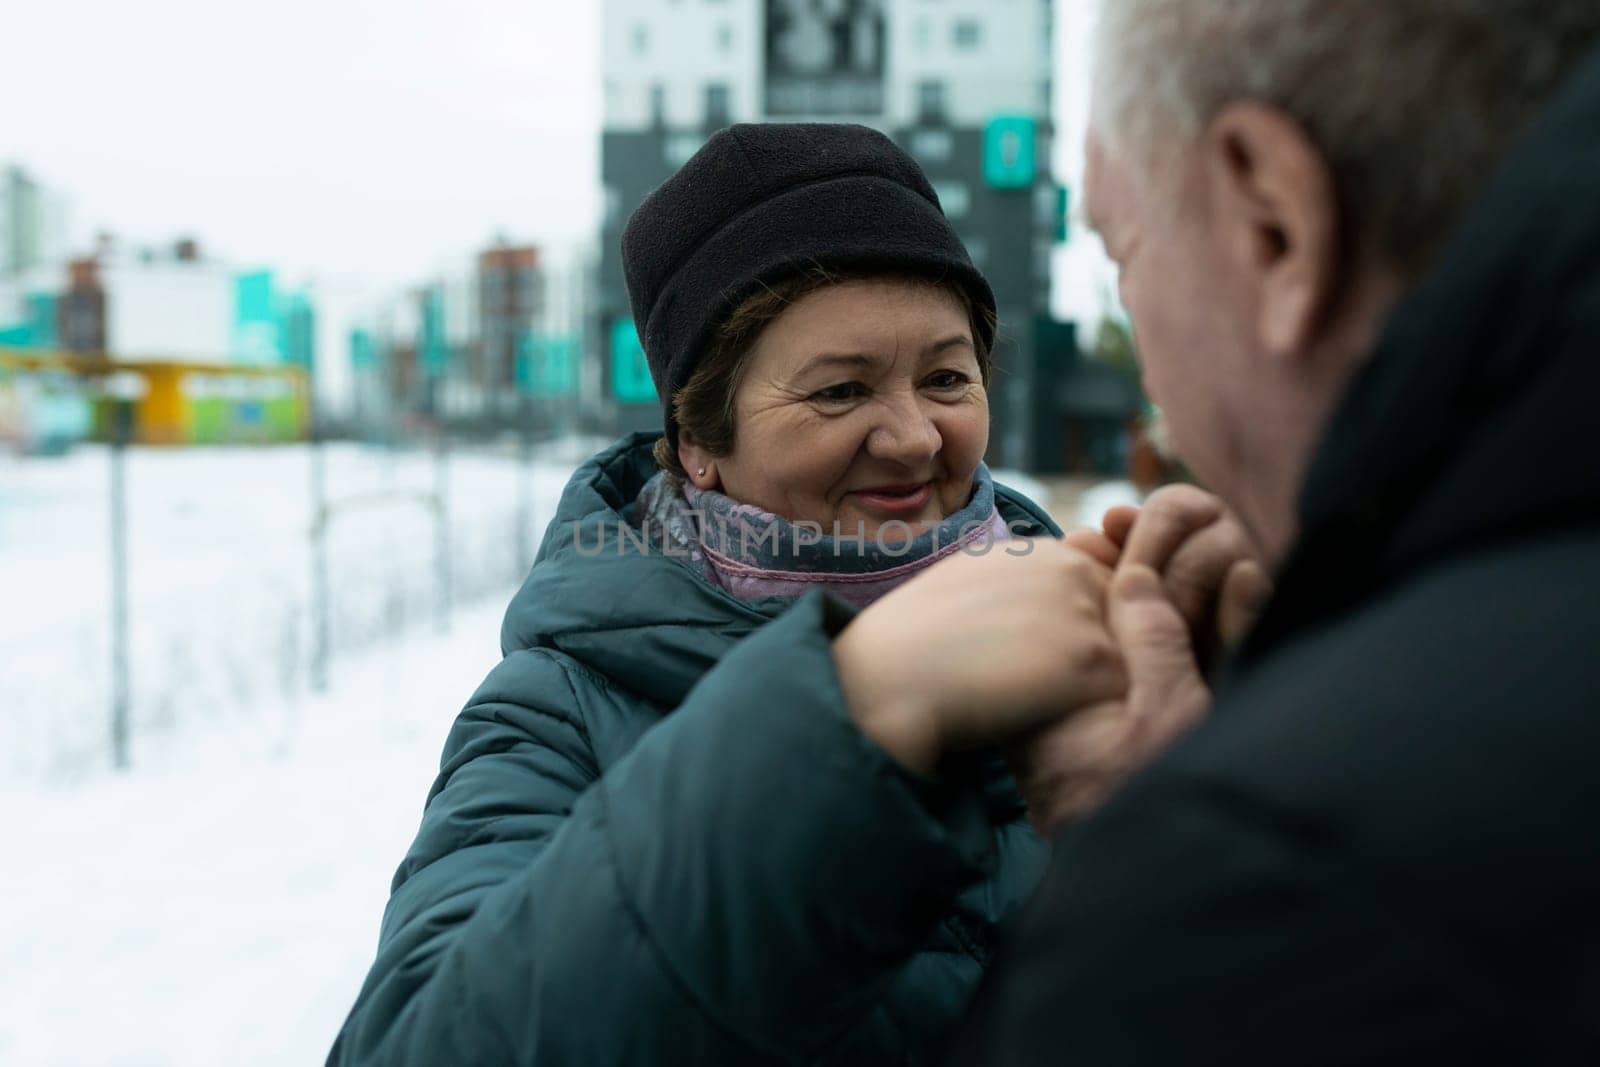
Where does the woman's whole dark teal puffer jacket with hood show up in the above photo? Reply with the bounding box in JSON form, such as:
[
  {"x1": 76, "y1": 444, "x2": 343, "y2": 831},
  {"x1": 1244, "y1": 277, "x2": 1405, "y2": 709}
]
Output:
[{"x1": 328, "y1": 435, "x2": 1059, "y2": 1067}]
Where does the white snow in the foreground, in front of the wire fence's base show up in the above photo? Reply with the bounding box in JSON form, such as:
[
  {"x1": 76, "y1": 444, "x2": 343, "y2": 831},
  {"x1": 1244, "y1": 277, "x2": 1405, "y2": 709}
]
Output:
[{"x1": 0, "y1": 590, "x2": 509, "y2": 1067}]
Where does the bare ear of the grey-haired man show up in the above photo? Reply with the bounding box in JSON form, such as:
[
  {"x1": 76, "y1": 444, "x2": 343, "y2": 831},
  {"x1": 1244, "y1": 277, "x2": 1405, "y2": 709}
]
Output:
[{"x1": 1200, "y1": 102, "x2": 1341, "y2": 358}]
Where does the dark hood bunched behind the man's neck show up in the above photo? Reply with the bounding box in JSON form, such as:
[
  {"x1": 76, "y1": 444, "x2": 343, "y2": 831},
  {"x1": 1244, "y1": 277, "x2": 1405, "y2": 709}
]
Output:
[{"x1": 1245, "y1": 47, "x2": 1600, "y2": 659}]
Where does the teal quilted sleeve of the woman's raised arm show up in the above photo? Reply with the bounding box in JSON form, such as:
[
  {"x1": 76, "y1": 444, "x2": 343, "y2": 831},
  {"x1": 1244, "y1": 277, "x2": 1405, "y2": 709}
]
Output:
[{"x1": 330, "y1": 595, "x2": 994, "y2": 1065}]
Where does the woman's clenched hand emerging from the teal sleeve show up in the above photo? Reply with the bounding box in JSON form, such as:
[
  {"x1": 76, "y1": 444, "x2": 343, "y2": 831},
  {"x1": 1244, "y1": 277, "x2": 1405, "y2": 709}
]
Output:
[{"x1": 834, "y1": 539, "x2": 1126, "y2": 776}]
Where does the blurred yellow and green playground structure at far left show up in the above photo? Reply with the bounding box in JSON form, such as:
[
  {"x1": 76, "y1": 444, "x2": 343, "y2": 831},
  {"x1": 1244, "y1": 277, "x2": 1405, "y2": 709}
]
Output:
[{"x1": 0, "y1": 347, "x2": 310, "y2": 453}]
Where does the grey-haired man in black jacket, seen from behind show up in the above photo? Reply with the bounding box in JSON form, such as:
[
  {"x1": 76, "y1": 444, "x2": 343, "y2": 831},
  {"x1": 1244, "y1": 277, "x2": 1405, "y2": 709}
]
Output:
[{"x1": 957, "y1": 0, "x2": 1600, "y2": 1067}]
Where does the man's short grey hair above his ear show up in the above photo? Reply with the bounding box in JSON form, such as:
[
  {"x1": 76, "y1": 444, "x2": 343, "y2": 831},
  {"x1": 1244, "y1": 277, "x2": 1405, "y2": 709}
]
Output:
[{"x1": 1094, "y1": 0, "x2": 1600, "y2": 275}]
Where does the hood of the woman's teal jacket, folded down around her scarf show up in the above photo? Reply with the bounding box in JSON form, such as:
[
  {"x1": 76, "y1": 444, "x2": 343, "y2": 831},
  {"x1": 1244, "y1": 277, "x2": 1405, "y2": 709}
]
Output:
[{"x1": 501, "y1": 432, "x2": 1059, "y2": 705}]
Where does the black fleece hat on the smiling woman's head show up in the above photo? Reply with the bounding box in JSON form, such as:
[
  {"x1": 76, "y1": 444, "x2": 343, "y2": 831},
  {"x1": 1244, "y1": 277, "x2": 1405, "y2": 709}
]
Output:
[{"x1": 622, "y1": 123, "x2": 995, "y2": 442}]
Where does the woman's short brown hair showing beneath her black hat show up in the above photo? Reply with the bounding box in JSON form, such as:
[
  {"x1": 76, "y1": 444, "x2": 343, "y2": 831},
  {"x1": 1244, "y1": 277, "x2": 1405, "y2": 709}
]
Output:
[{"x1": 654, "y1": 266, "x2": 994, "y2": 478}]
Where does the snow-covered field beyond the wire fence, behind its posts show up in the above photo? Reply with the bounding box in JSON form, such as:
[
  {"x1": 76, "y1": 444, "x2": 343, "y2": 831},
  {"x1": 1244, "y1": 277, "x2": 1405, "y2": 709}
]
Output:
[{"x1": 0, "y1": 445, "x2": 595, "y2": 781}]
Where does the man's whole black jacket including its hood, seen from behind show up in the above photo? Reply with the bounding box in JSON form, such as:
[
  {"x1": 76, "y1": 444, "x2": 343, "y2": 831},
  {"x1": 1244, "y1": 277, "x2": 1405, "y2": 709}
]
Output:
[{"x1": 954, "y1": 45, "x2": 1600, "y2": 1067}]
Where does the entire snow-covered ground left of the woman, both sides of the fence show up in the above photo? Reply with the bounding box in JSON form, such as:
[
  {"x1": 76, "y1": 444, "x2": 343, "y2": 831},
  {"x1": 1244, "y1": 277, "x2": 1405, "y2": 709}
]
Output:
[{"x1": 0, "y1": 445, "x2": 584, "y2": 1067}]
